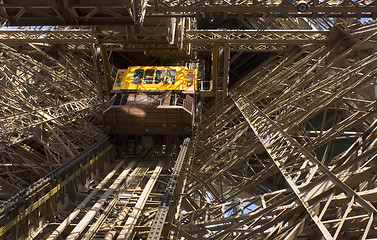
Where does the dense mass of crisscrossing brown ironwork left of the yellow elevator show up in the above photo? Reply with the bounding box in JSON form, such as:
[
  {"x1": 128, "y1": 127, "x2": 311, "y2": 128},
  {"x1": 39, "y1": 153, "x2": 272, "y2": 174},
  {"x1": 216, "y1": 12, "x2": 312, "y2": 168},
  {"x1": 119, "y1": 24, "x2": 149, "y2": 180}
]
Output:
[{"x1": 0, "y1": 44, "x2": 104, "y2": 199}]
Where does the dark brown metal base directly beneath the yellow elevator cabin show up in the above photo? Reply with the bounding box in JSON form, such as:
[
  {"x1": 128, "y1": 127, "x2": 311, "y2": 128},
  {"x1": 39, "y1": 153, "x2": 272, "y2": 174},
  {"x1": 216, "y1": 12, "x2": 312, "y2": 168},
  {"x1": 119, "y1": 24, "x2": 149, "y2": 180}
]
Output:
[{"x1": 103, "y1": 92, "x2": 194, "y2": 136}]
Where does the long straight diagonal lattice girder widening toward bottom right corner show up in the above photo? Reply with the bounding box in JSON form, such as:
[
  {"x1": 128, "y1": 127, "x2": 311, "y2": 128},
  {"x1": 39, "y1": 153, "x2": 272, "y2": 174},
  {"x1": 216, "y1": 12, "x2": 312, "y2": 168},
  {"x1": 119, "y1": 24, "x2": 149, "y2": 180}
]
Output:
[{"x1": 231, "y1": 95, "x2": 377, "y2": 239}]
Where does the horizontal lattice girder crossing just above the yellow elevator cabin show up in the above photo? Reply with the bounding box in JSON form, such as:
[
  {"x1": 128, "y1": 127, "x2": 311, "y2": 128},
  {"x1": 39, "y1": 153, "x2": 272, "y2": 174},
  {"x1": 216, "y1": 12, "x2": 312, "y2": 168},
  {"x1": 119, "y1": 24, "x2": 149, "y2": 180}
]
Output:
[{"x1": 0, "y1": 28, "x2": 329, "y2": 52}]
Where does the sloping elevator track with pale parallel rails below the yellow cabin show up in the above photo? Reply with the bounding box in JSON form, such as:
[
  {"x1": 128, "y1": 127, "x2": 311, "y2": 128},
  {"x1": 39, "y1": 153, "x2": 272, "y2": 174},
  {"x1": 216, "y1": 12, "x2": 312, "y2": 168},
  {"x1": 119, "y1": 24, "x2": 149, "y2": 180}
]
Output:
[{"x1": 1, "y1": 139, "x2": 189, "y2": 240}]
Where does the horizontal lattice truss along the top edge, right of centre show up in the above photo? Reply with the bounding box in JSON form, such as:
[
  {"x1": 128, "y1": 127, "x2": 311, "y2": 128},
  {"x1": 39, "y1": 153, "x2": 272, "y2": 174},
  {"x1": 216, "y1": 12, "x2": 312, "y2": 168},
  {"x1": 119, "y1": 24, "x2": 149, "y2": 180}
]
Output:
[{"x1": 150, "y1": 0, "x2": 377, "y2": 18}]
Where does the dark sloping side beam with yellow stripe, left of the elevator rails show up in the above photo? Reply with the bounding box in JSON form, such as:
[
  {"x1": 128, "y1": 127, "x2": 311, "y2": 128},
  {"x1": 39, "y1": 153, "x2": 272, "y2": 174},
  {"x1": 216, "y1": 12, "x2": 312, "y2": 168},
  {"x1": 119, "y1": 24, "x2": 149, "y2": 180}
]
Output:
[{"x1": 0, "y1": 138, "x2": 114, "y2": 238}]
